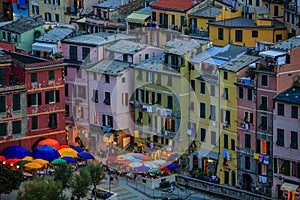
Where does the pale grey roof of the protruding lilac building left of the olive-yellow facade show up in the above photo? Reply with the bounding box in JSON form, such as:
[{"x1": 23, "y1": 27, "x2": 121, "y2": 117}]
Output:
[{"x1": 87, "y1": 60, "x2": 129, "y2": 76}]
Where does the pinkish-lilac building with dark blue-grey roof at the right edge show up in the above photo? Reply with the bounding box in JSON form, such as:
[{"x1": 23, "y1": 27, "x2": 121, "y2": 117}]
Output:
[{"x1": 273, "y1": 86, "x2": 300, "y2": 199}]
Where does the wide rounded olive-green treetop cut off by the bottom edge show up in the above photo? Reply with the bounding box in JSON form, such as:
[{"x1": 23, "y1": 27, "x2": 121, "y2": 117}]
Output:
[{"x1": 17, "y1": 178, "x2": 68, "y2": 200}]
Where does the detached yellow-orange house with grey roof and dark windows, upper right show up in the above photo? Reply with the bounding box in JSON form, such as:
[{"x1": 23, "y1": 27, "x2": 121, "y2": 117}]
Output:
[{"x1": 208, "y1": 6, "x2": 287, "y2": 48}]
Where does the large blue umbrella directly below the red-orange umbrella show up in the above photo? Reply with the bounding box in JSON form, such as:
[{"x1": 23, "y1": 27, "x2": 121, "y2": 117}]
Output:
[{"x1": 32, "y1": 145, "x2": 60, "y2": 162}]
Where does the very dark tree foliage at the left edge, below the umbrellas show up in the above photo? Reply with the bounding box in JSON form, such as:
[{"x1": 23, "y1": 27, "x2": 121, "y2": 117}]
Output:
[{"x1": 0, "y1": 165, "x2": 22, "y2": 195}]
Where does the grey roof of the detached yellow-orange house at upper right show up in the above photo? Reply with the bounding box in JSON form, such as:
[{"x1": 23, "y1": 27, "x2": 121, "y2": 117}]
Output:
[{"x1": 208, "y1": 17, "x2": 286, "y2": 29}]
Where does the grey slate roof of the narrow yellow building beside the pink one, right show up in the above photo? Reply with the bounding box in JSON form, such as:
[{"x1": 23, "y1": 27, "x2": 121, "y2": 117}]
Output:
[{"x1": 219, "y1": 54, "x2": 260, "y2": 72}]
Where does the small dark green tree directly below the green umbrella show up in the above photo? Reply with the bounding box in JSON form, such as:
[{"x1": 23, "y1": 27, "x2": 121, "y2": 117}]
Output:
[{"x1": 54, "y1": 164, "x2": 74, "y2": 189}]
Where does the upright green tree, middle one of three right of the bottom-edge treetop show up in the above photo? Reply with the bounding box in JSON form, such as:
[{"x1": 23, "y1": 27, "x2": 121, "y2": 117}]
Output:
[{"x1": 70, "y1": 168, "x2": 92, "y2": 199}]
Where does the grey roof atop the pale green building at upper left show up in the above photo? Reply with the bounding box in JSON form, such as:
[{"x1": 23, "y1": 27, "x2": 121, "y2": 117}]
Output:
[{"x1": 0, "y1": 17, "x2": 43, "y2": 34}]
